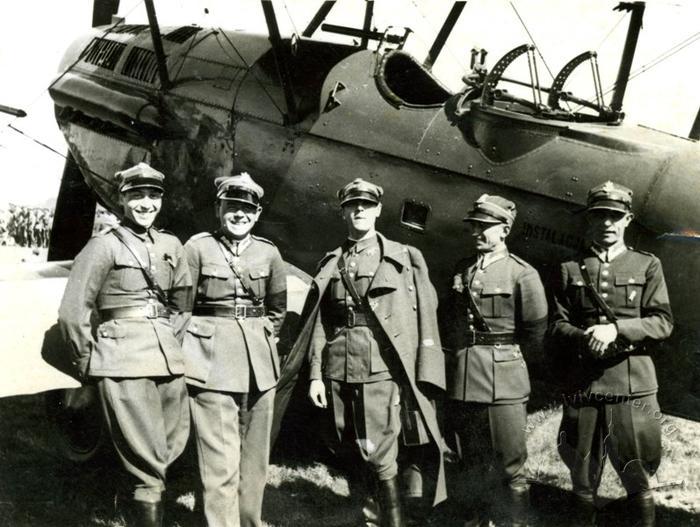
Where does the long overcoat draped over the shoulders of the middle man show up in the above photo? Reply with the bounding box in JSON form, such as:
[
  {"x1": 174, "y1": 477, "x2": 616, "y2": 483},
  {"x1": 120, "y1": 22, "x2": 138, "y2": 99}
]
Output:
[{"x1": 281, "y1": 234, "x2": 446, "y2": 503}]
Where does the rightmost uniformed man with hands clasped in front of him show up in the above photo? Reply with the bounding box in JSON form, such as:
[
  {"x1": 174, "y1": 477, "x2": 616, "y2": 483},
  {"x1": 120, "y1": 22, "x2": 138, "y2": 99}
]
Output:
[{"x1": 551, "y1": 181, "x2": 673, "y2": 526}]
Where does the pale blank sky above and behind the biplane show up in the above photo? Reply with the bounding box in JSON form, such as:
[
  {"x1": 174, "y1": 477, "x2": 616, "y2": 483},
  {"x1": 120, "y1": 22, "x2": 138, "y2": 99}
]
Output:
[{"x1": 0, "y1": 0, "x2": 700, "y2": 209}]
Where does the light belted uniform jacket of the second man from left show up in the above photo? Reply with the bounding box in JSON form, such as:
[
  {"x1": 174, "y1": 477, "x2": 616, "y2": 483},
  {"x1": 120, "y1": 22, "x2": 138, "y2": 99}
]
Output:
[{"x1": 183, "y1": 233, "x2": 287, "y2": 392}]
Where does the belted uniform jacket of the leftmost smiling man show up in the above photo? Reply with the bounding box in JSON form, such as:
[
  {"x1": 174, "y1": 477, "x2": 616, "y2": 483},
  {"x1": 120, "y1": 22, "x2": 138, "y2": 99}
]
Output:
[{"x1": 58, "y1": 225, "x2": 192, "y2": 377}]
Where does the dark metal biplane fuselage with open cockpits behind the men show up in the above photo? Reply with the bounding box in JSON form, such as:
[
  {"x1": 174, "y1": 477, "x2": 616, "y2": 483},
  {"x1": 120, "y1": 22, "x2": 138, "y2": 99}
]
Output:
[{"x1": 43, "y1": 25, "x2": 700, "y2": 414}]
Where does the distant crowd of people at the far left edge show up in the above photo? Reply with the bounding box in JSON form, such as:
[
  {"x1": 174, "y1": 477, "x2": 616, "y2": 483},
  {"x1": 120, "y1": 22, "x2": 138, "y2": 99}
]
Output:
[{"x1": 0, "y1": 205, "x2": 53, "y2": 247}]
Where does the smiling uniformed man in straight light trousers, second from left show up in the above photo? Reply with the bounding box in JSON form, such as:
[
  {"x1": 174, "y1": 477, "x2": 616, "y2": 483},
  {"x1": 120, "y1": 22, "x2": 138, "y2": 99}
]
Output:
[{"x1": 183, "y1": 172, "x2": 287, "y2": 527}]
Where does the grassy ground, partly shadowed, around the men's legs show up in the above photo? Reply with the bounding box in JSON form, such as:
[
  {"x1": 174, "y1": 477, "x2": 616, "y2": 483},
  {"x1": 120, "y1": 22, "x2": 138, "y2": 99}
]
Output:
[{"x1": 0, "y1": 395, "x2": 700, "y2": 527}]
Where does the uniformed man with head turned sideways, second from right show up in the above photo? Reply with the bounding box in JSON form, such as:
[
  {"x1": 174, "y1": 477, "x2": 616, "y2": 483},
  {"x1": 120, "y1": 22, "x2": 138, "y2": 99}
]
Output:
[{"x1": 447, "y1": 194, "x2": 547, "y2": 525}]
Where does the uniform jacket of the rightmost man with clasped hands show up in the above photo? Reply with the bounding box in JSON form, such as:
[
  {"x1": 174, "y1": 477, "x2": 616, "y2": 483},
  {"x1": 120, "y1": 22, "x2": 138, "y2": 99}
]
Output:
[{"x1": 551, "y1": 249, "x2": 673, "y2": 396}]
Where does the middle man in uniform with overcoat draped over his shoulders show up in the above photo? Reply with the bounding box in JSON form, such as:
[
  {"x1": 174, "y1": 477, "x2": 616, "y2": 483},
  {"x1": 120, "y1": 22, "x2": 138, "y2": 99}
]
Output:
[{"x1": 291, "y1": 179, "x2": 445, "y2": 527}]
